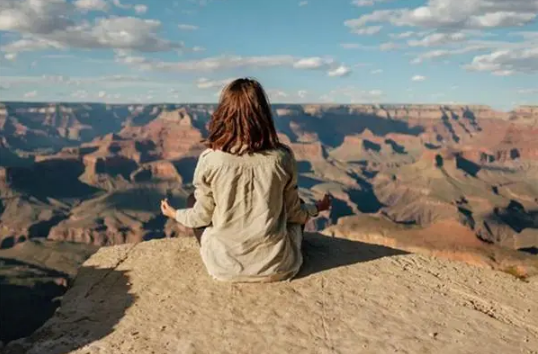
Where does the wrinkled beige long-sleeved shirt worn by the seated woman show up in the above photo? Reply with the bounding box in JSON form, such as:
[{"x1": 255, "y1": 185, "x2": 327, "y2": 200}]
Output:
[{"x1": 176, "y1": 149, "x2": 317, "y2": 282}]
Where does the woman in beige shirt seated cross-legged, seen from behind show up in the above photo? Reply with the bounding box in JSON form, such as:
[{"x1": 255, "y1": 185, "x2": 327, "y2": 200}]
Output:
[{"x1": 161, "y1": 79, "x2": 330, "y2": 282}]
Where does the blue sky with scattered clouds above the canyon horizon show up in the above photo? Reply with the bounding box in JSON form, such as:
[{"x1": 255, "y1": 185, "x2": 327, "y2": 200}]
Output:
[{"x1": 0, "y1": 0, "x2": 538, "y2": 110}]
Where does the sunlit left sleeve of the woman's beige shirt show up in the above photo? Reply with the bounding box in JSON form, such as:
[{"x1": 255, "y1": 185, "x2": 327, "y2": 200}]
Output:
[{"x1": 175, "y1": 156, "x2": 215, "y2": 228}]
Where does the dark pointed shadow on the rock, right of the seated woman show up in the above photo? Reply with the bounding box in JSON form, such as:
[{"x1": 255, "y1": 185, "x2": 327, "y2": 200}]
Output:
[{"x1": 296, "y1": 233, "x2": 408, "y2": 279}]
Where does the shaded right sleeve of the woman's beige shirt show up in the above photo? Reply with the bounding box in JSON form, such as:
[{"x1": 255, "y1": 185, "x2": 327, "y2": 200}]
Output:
[{"x1": 284, "y1": 152, "x2": 318, "y2": 225}]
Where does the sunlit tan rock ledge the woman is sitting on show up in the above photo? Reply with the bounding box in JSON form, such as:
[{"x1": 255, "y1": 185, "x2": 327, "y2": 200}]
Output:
[{"x1": 4, "y1": 234, "x2": 538, "y2": 354}]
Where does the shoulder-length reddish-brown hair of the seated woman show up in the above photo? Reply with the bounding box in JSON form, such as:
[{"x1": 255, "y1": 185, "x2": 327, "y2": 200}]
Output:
[{"x1": 205, "y1": 78, "x2": 282, "y2": 155}]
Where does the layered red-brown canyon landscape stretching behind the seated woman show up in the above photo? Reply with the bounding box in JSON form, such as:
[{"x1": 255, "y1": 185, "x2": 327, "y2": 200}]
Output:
[{"x1": 0, "y1": 102, "x2": 538, "y2": 342}]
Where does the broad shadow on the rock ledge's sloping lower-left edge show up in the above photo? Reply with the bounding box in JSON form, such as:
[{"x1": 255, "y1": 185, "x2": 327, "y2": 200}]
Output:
[{"x1": 3, "y1": 266, "x2": 135, "y2": 354}]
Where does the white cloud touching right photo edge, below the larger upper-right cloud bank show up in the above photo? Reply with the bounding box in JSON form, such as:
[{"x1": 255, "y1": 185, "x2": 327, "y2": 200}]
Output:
[{"x1": 465, "y1": 45, "x2": 538, "y2": 76}]
